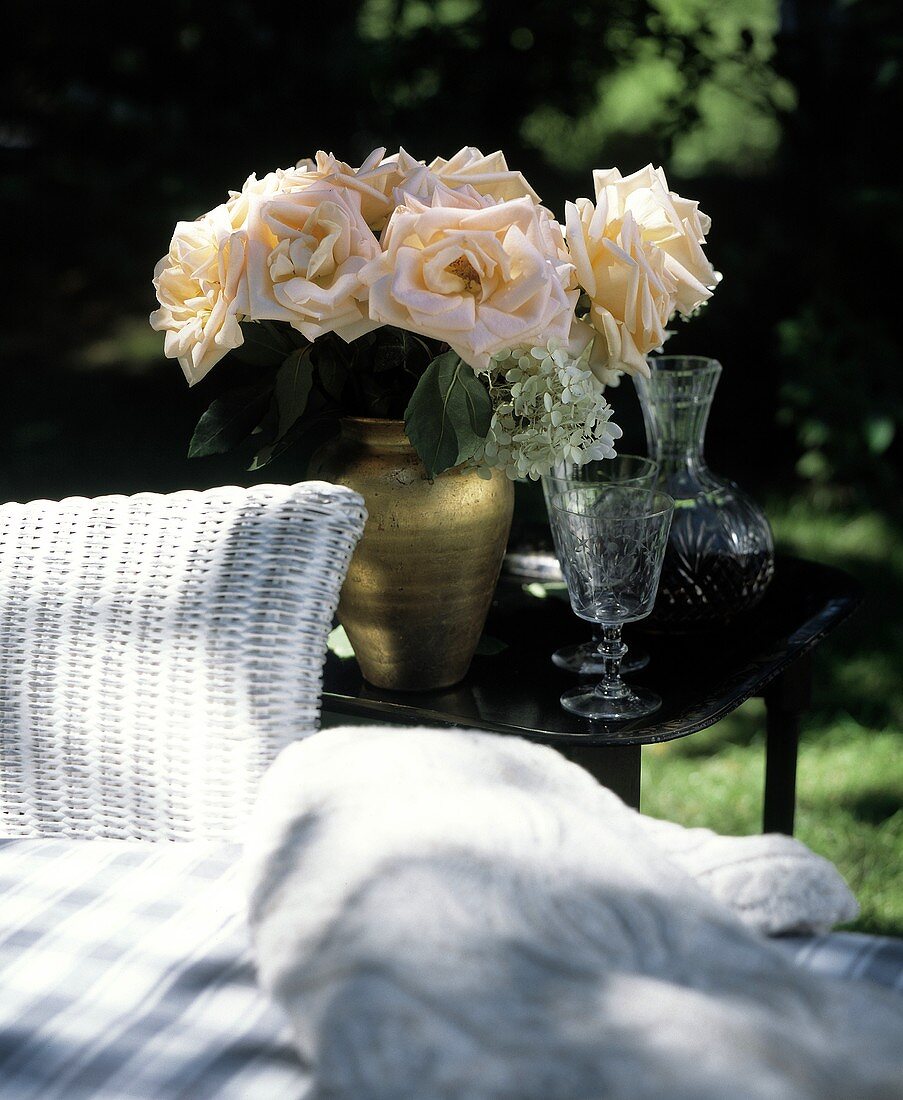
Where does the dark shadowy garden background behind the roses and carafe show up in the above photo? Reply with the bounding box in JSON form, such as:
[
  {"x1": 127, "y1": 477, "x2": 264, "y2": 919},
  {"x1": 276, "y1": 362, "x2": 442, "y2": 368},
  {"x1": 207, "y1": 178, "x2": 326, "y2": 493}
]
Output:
[{"x1": 0, "y1": 0, "x2": 903, "y2": 512}]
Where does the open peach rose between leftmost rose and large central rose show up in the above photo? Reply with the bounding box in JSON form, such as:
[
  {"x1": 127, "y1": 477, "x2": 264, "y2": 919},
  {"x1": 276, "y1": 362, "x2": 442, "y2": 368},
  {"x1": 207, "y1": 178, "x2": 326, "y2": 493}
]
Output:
[{"x1": 240, "y1": 183, "x2": 379, "y2": 342}]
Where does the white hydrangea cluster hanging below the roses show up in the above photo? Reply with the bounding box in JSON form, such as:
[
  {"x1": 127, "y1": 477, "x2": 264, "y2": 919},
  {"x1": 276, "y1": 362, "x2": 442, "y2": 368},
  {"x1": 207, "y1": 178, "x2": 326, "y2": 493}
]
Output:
[{"x1": 467, "y1": 340, "x2": 623, "y2": 481}]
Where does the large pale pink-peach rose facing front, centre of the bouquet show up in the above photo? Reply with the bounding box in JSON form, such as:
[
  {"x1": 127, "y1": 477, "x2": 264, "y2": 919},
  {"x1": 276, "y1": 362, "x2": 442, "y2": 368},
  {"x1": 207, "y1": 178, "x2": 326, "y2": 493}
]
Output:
[{"x1": 361, "y1": 187, "x2": 577, "y2": 370}]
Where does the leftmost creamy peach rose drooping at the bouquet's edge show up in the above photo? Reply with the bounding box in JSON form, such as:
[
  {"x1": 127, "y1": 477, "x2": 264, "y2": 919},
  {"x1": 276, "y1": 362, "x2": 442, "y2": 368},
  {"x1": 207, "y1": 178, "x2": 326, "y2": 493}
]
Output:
[{"x1": 151, "y1": 204, "x2": 247, "y2": 385}]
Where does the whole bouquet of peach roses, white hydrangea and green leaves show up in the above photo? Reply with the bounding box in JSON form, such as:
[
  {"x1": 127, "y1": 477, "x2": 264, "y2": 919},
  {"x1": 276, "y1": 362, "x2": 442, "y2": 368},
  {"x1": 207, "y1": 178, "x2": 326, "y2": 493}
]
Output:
[{"x1": 151, "y1": 147, "x2": 720, "y2": 480}]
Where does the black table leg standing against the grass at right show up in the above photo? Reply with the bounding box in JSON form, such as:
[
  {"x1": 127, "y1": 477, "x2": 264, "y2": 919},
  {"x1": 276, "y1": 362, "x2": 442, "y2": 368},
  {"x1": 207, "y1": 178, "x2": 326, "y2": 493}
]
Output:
[{"x1": 762, "y1": 653, "x2": 812, "y2": 836}]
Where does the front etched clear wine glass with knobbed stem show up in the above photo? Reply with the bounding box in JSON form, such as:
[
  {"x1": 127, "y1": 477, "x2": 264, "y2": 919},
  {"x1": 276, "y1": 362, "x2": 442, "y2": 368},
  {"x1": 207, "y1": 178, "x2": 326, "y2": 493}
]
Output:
[{"x1": 549, "y1": 484, "x2": 674, "y2": 722}]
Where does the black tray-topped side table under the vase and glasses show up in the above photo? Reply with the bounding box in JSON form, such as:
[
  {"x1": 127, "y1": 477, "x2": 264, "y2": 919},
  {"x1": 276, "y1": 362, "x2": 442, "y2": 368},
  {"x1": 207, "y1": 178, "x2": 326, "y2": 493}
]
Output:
[{"x1": 323, "y1": 557, "x2": 862, "y2": 834}]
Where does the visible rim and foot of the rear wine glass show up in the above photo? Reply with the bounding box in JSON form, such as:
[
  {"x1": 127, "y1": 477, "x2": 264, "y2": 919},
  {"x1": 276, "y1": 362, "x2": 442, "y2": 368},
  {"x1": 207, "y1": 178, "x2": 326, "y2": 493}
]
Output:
[{"x1": 542, "y1": 454, "x2": 659, "y2": 677}]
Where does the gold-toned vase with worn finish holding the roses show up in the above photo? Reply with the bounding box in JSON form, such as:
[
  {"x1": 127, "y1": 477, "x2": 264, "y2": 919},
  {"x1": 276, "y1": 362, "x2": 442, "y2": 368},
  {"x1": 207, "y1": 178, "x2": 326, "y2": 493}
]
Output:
[{"x1": 309, "y1": 417, "x2": 514, "y2": 691}]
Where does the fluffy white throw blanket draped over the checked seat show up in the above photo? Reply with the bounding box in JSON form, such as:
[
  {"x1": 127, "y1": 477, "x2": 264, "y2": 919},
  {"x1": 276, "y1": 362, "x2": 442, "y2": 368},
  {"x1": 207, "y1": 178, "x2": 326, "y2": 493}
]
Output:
[{"x1": 239, "y1": 726, "x2": 903, "y2": 1100}]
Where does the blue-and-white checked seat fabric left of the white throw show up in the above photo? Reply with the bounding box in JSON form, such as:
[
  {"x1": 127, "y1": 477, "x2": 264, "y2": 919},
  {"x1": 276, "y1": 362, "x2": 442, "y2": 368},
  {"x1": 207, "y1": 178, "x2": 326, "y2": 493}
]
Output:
[{"x1": 0, "y1": 839, "x2": 309, "y2": 1100}]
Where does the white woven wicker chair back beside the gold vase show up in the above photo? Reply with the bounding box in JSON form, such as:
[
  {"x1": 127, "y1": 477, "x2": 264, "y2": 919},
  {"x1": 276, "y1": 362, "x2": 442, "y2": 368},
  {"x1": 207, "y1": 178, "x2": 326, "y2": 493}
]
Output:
[{"x1": 0, "y1": 482, "x2": 366, "y2": 840}]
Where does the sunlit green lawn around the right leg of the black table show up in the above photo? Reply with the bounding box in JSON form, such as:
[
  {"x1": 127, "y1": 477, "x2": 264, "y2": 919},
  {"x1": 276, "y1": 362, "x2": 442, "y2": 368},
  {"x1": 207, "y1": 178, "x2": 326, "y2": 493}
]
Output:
[{"x1": 642, "y1": 501, "x2": 903, "y2": 936}]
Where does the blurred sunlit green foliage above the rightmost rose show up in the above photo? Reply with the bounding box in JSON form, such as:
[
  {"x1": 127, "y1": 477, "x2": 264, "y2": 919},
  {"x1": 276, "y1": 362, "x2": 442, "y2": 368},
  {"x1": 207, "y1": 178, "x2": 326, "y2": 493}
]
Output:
[{"x1": 522, "y1": 0, "x2": 796, "y2": 178}]
